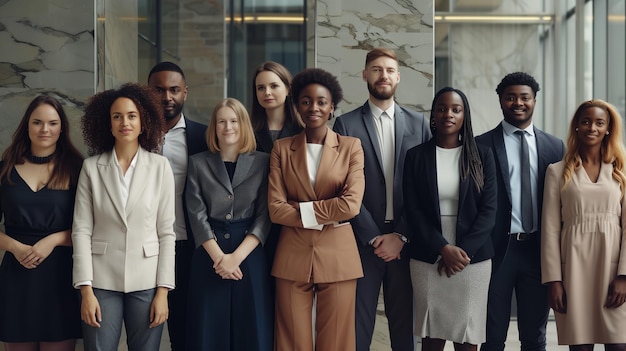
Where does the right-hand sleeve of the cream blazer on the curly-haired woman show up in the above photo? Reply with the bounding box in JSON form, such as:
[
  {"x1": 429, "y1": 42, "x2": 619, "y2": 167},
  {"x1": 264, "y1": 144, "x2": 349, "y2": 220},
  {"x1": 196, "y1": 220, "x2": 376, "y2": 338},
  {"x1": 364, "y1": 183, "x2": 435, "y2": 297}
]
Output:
[{"x1": 156, "y1": 157, "x2": 176, "y2": 287}]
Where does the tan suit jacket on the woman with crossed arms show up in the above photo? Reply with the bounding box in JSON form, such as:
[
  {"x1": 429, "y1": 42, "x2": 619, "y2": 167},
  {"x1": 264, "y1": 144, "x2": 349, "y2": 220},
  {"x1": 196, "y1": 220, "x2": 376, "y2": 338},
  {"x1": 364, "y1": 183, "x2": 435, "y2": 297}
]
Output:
[{"x1": 268, "y1": 128, "x2": 365, "y2": 283}]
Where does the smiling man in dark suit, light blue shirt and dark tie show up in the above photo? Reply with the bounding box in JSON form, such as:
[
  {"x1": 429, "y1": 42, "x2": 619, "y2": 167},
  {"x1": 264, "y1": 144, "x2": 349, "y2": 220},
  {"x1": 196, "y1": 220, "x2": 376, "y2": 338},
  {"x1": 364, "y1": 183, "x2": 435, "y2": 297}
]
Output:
[{"x1": 477, "y1": 72, "x2": 565, "y2": 351}]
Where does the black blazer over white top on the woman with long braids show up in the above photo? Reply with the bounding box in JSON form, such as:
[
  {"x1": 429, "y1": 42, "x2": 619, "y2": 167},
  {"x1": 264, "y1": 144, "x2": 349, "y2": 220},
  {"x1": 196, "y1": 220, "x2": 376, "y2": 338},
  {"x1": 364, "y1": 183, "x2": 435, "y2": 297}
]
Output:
[{"x1": 404, "y1": 138, "x2": 497, "y2": 263}]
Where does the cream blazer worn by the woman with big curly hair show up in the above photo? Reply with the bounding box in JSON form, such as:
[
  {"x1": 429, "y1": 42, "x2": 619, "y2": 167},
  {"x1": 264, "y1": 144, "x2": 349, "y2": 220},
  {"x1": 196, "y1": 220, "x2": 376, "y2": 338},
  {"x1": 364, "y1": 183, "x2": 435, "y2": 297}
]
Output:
[{"x1": 72, "y1": 147, "x2": 176, "y2": 292}]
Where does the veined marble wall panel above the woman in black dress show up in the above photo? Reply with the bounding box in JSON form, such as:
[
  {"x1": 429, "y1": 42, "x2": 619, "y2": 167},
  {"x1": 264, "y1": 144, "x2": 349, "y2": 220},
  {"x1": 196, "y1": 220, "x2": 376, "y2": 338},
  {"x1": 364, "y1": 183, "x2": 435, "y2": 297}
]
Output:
[{"x1": 0, "y1": 0, "x2": 95, "y2": 155}]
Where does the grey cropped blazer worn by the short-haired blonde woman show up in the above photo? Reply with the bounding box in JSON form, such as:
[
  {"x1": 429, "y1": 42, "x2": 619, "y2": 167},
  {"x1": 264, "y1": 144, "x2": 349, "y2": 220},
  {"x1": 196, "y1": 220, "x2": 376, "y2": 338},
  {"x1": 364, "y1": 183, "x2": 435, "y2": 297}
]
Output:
[{"x1": 185, "y1": 151, "x2": 270, "y2": 247}]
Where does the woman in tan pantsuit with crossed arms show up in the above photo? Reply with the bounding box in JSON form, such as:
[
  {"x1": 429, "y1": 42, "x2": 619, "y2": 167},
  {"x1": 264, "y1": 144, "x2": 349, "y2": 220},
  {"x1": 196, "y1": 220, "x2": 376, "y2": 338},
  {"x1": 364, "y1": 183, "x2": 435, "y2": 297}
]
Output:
[{"x1": 268, "y1": 69, "x2": 365, "y2": 351}]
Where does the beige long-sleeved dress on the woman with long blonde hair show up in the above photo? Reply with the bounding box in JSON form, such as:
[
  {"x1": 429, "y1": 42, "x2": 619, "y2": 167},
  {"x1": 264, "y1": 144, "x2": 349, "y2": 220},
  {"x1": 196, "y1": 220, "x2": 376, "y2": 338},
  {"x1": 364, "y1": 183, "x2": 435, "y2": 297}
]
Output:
[{"x1": 541, "y1": 161, "x2": 626, "y2": 345}]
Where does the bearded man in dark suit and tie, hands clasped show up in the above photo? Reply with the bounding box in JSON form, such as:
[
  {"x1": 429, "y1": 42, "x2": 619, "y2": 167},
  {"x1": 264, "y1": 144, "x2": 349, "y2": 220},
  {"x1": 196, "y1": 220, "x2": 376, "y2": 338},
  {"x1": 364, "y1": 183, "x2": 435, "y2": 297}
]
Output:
[{"x1": 333, "y1": 49, "x2": 431, "y2": 351}]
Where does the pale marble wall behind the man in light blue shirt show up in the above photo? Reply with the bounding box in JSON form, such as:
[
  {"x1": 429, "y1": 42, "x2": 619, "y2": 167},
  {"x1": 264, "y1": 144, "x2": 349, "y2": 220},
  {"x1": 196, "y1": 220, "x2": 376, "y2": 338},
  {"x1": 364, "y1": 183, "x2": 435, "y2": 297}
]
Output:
[{"x1": 448, "y1": 0, "x2": 547, "y2": 135}]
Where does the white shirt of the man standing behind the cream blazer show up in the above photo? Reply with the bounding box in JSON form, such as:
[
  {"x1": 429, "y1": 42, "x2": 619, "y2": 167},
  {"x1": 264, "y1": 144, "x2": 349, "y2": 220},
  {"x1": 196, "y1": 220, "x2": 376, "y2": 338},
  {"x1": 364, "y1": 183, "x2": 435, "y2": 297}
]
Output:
[{"x1": 163, "y1": 115, "x2": 188, "y2": 240}]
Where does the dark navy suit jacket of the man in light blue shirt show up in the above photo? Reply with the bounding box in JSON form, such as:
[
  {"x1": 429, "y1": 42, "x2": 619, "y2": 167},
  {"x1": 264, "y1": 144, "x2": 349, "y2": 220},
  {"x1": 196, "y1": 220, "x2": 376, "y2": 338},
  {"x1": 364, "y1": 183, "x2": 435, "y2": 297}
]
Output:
[{"x1": 476, "y1": 123, "x2": 565, "y2": 272}]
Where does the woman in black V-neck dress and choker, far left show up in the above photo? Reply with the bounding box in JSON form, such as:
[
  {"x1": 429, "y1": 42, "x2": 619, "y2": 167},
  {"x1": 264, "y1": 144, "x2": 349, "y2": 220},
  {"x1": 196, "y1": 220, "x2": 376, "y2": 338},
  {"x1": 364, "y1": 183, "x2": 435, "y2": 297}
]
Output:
[{"x1": 0, "y1": 95, "x2": 83, "y2": 351}]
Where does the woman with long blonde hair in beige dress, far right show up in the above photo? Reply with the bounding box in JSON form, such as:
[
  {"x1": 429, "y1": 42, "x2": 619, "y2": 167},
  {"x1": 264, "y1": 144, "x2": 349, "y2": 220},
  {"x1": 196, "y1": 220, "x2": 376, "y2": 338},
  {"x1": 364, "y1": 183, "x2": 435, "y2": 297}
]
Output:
[{"x1": 541, "y1": 100, "x2": 626, "y2": 351}]
